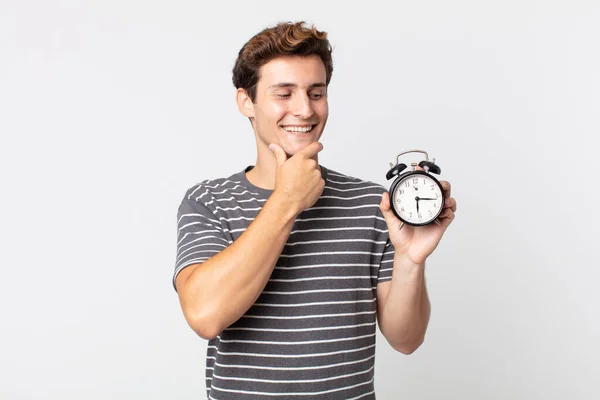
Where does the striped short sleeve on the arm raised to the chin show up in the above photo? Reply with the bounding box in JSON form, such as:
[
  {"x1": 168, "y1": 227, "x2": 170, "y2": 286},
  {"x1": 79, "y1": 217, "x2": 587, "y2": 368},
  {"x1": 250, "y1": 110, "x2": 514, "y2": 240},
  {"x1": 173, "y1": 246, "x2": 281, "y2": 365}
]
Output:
[{"x1": 173, "y1": 198, "x2": 229, "y2": 290}]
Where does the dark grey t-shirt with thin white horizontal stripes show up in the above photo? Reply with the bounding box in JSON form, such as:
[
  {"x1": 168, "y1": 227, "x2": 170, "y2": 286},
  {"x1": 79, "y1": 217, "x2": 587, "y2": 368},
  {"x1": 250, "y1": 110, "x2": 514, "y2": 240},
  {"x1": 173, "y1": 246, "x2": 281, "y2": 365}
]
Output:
[{"x1": 173, "y1": 166, "x2": 394, "y2": 400}]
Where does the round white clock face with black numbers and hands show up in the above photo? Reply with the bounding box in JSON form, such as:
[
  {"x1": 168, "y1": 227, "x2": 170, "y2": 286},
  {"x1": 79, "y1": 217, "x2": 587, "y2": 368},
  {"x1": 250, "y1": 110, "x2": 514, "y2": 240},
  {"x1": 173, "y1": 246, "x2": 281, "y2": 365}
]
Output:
[{"x1": 392, "y1": 173, "x2": 444, "y2": 225}]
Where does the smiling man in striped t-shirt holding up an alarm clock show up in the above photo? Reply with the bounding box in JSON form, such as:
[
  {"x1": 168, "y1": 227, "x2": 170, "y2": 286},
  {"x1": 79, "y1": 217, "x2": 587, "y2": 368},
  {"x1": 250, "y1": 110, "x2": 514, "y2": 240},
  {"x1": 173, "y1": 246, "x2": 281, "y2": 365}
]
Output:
[{"x1": 173, "y1": 22, "x2": 456, "y2": 399}]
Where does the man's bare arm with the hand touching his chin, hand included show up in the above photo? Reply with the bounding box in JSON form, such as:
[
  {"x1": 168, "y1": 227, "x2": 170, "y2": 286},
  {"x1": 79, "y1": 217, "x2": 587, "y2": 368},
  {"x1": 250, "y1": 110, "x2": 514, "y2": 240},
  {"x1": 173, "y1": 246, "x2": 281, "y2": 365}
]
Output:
[{"x1": 176, "y1": 143, "x2": 325, "y2": 339}]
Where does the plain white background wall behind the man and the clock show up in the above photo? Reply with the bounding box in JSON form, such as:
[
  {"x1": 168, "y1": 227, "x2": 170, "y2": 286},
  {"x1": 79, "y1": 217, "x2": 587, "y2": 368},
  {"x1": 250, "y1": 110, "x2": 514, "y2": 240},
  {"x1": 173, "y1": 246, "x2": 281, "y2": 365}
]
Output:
[{"x1": 0, "y1": 0, "x2": 600, "y2": 400}]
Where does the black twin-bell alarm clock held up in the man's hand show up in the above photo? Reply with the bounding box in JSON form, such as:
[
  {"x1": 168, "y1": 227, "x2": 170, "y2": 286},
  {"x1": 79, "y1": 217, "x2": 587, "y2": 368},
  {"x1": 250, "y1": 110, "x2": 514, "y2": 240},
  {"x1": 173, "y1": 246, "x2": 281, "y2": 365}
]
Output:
[{"x1": 386, "y1": 150, "x2": 445, "y2": 226}]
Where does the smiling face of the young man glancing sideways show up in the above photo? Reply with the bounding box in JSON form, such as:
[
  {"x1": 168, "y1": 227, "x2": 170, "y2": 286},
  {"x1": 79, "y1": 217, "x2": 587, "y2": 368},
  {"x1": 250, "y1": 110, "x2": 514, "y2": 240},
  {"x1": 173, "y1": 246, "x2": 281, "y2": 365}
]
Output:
[{"x1": 245, "y1": 55, "x2": 329, "y2": 157}]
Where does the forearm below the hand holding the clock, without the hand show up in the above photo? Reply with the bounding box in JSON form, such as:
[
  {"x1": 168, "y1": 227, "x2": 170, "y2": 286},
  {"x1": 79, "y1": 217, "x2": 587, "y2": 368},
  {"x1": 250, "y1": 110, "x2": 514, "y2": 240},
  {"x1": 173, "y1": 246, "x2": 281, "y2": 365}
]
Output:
[{"x1": 380, "y1": 252, "x2": 431, "y2": 352}]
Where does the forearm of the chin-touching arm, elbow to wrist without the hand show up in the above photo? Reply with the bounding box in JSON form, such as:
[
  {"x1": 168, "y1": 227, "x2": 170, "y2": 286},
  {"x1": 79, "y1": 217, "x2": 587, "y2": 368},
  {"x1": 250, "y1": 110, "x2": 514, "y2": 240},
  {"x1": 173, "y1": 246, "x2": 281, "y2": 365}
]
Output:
[{"x1": 178, "y1": 196, "x2": 296, "y2": 339}]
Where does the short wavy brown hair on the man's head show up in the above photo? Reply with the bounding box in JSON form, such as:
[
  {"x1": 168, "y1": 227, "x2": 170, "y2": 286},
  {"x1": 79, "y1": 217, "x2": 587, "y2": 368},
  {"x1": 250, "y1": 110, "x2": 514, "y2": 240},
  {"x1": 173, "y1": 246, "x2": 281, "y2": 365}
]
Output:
[{"x1": 233, "y1": 21, "x2": 333, "y2": 102}]
